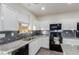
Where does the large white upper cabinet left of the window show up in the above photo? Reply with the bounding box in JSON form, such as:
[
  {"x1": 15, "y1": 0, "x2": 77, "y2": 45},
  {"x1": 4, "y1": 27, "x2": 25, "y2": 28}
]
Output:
[{"x1": 1, "y1": 5, "x2": 17, "y2": 30}]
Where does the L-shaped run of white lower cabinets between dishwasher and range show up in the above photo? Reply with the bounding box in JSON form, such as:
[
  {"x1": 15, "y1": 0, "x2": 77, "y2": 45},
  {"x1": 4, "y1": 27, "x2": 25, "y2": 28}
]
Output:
[{"x1": 29, "y1": 37, "x2": 49, "y2": 55}]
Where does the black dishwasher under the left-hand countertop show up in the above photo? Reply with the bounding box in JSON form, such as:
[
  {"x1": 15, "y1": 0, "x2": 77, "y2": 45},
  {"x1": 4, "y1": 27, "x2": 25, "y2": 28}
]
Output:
[{"x1": 12, "y1": 44, "x2": 29, "y2": 55}]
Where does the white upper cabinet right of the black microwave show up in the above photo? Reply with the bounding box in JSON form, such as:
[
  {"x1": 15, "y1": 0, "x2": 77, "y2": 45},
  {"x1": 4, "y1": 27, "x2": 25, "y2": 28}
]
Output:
[{"x1": 62, "y1": 18, "x2": 77, "y2": 30}]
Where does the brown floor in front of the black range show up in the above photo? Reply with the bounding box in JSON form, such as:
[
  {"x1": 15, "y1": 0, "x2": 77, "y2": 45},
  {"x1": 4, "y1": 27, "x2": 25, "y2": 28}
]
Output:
[{"x1": 36, "y1": 48, "x2": 63, "y2": 55}]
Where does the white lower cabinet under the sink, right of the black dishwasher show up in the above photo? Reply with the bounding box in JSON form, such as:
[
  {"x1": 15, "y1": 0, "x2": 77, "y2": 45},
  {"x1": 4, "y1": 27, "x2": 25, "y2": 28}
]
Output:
[{"x1": 29, "y1": 39, "x2": 40, "y2": 55}]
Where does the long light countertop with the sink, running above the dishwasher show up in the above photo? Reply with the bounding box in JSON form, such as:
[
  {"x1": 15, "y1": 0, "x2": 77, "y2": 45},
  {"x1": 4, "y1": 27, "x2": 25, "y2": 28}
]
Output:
[{"x1": 0, "y1": 35, "x2": 47, "y2": 54}]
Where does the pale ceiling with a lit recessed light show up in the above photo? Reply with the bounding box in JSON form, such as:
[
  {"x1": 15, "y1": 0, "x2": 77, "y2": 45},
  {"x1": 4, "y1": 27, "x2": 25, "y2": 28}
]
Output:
[{"x1": 22, "y1": 3, "x2": 79, "y2": 16}]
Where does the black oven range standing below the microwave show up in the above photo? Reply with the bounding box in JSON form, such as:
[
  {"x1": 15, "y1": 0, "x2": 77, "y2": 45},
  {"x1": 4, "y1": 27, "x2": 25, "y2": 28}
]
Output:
[{"x1": 49, "y1": 32, "x2": 63, "y2": 52}]
